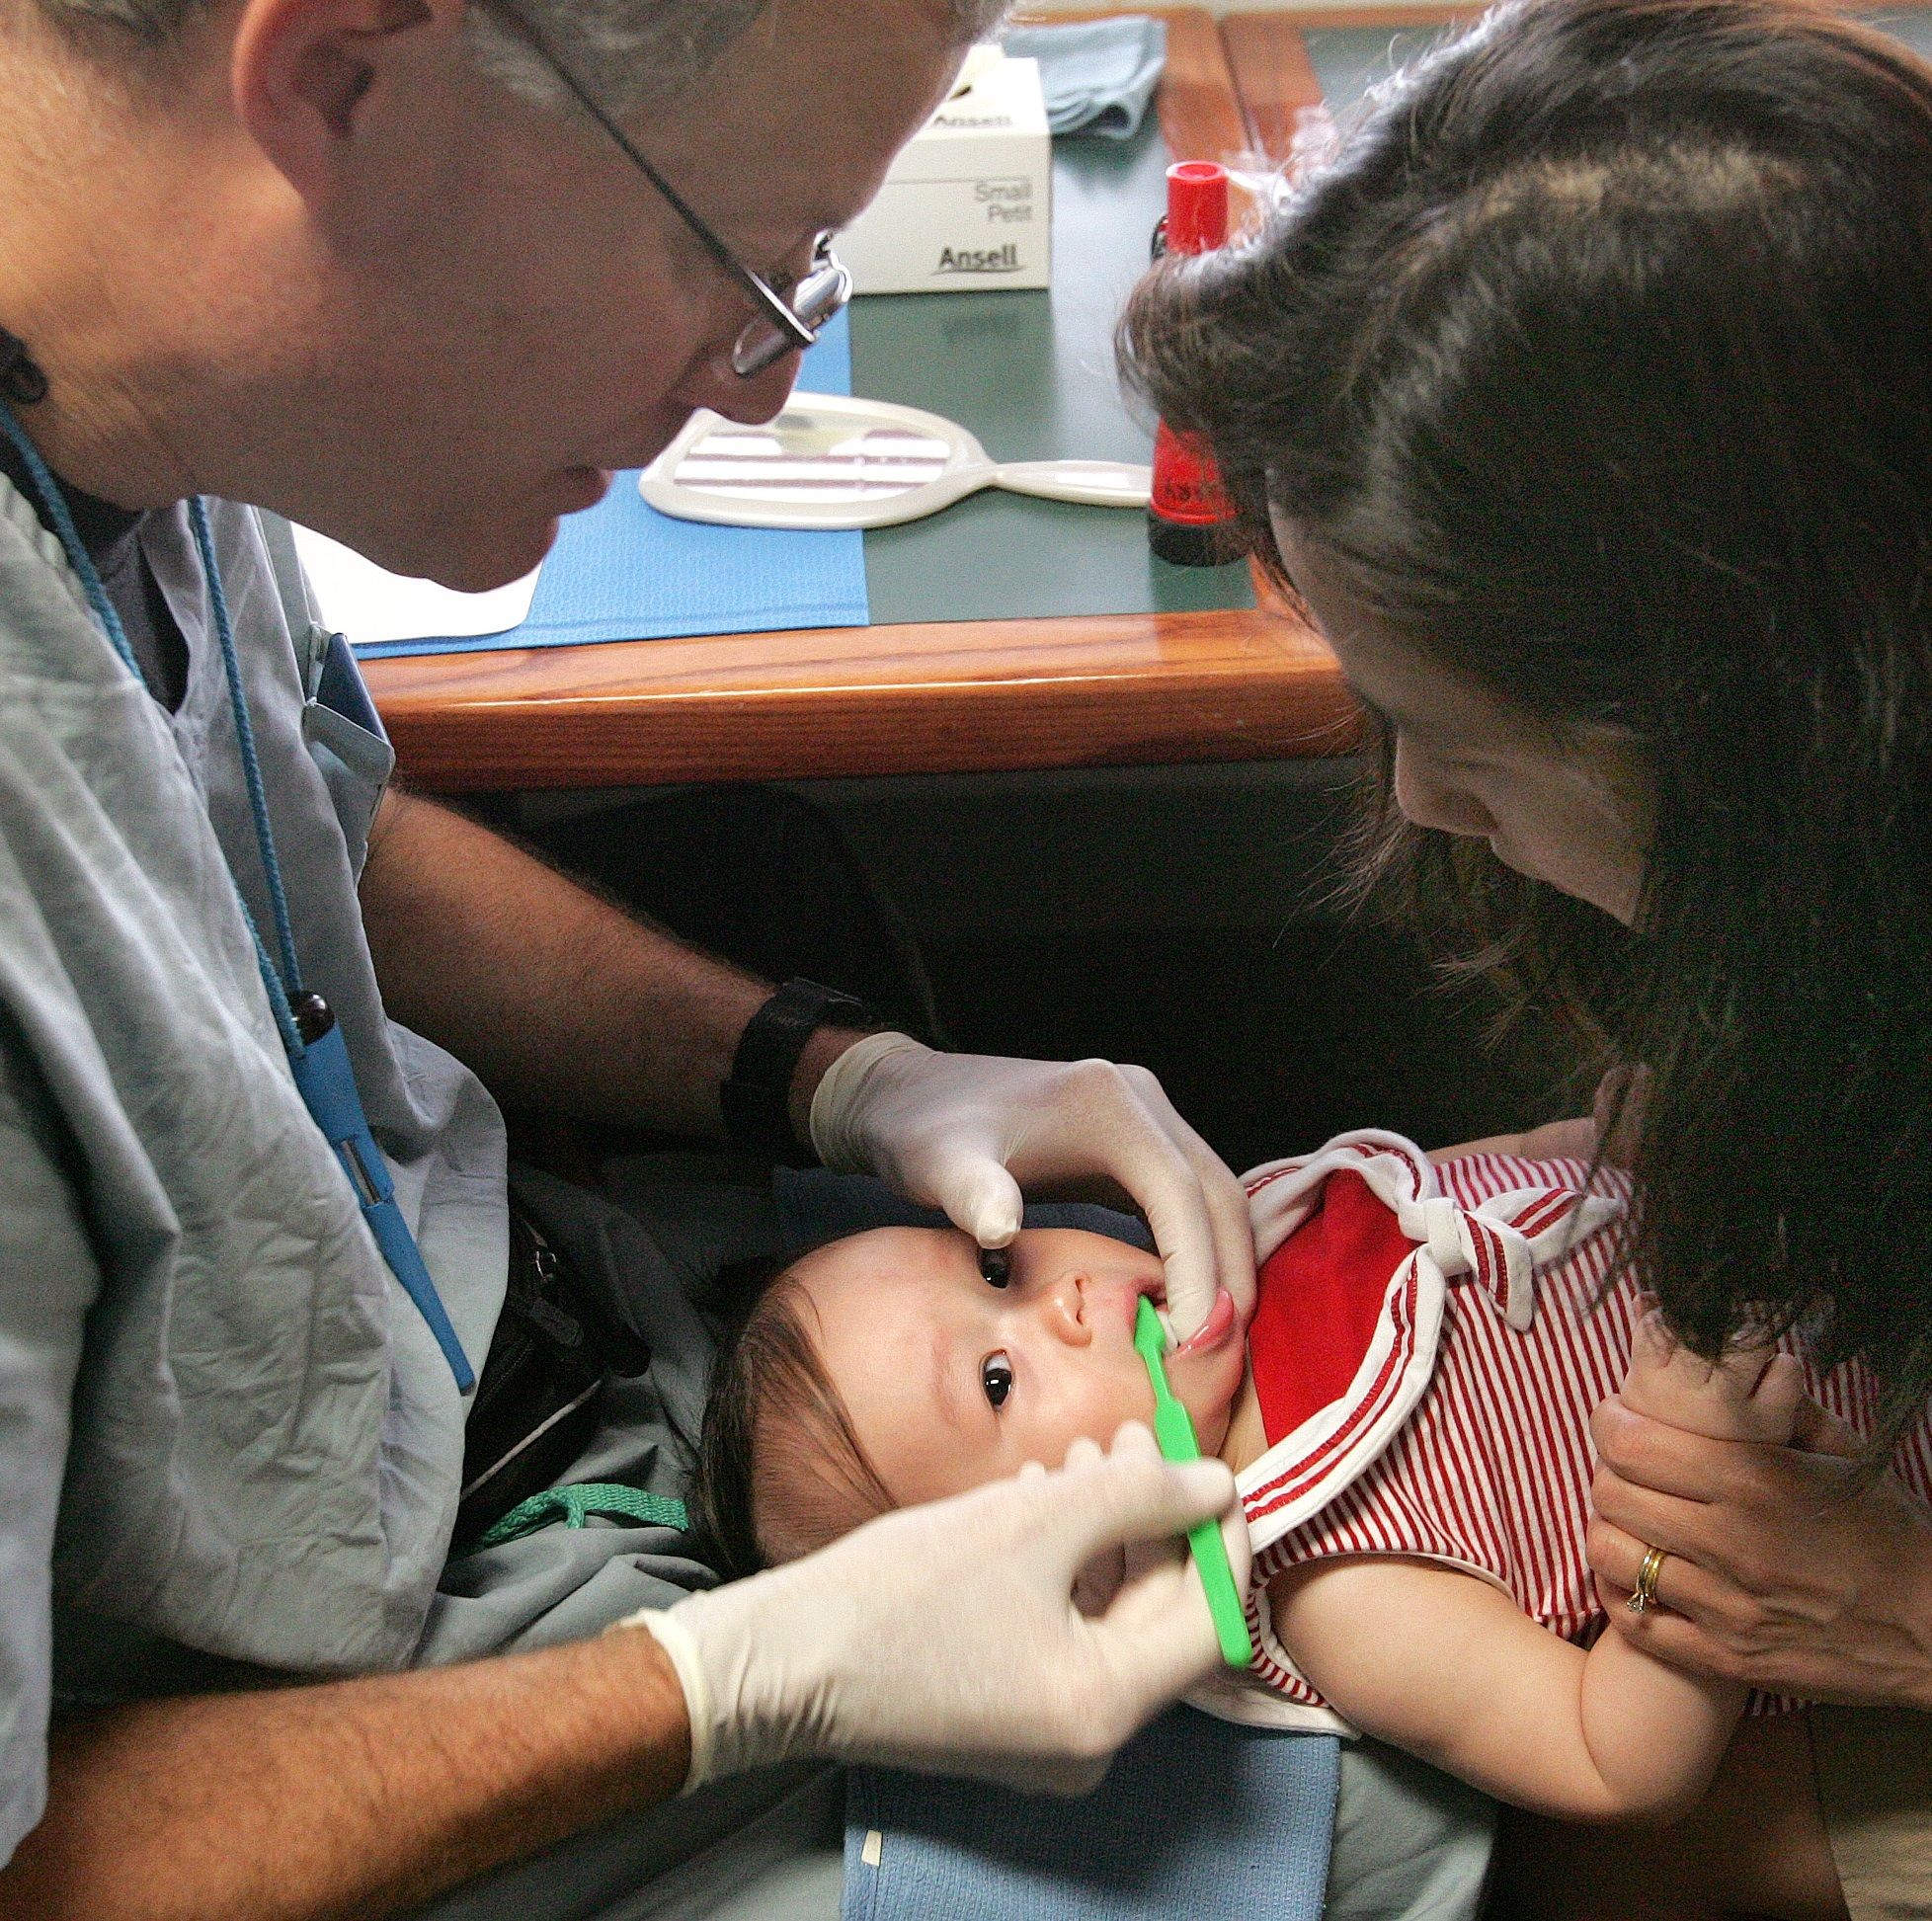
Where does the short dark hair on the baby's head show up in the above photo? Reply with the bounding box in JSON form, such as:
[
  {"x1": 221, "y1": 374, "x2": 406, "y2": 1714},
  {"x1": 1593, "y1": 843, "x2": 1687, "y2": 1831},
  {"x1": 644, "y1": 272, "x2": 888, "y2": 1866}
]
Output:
[{"x1": 691, "y1": 1250, "x2": 895, "y2": 1579}]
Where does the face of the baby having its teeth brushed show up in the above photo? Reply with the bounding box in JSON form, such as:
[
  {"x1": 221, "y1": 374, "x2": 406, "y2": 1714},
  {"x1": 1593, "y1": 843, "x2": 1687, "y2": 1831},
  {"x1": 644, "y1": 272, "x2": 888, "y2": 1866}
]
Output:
[{"x1": 794, "y1": 1228, "x2": 1247, "y2": 1505}]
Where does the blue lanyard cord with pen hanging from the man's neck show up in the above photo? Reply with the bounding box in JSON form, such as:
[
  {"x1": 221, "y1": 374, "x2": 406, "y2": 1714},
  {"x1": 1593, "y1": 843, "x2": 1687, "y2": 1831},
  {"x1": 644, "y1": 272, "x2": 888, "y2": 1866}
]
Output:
[{"x1": 0, "y1": 400, "x2": 475, "y2": 1394}]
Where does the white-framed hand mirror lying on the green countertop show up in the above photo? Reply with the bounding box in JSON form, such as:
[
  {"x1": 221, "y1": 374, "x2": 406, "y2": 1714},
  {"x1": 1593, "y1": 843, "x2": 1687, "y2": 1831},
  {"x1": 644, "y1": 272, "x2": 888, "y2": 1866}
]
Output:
[{"x1": 637, "y1": 394, "x2": 1152, "y2": 527}]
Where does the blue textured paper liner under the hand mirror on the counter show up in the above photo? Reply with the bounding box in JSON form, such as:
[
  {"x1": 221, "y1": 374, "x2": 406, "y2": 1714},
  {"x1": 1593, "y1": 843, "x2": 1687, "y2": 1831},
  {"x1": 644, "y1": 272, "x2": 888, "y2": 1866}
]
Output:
[{"x1": 356, "y1": 313, "x2": 871, "y2": 659}]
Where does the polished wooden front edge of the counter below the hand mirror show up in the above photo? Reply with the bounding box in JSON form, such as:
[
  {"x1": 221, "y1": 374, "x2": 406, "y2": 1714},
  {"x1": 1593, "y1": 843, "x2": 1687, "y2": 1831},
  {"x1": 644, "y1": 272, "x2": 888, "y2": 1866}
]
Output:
[{"x1": 369, "y1": 612, "x2": 1356, "y2": 792}]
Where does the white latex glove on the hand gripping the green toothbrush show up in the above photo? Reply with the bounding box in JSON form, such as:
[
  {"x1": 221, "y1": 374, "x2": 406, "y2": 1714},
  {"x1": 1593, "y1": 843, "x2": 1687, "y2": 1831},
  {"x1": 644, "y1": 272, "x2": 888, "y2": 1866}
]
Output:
[{"x1": 618, "y1": 1424, "x2": 1247, "y2": 1794}]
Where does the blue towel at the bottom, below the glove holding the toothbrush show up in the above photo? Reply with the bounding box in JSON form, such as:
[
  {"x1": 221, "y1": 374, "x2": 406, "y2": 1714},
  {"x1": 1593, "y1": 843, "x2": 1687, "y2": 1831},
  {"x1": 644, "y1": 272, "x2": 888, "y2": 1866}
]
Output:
[{"x1": 841, "y1": 1708, "x2": 1340, "y2": 1921}]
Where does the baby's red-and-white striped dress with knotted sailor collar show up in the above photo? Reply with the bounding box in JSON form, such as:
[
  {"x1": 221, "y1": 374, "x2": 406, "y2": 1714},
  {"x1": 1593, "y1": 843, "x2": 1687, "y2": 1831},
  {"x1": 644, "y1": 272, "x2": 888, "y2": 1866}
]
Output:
[{"x1": 1196, "y1": 1131, "x2": 1932, "y2": 1729}]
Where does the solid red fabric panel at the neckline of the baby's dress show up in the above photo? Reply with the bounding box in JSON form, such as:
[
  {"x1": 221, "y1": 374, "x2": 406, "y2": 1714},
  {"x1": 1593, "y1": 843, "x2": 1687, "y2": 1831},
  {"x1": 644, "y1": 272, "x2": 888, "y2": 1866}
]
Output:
[{"x1": 1248, "y1": 1169, "x2": 1414, "y2": 1446}]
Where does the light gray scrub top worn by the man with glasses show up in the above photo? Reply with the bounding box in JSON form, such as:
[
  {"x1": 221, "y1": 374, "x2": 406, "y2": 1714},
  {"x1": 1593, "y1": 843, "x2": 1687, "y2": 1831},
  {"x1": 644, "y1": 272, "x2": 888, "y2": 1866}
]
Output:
[{"x1": 0, "y1": 481, "x2": 506, "y2": 1861}]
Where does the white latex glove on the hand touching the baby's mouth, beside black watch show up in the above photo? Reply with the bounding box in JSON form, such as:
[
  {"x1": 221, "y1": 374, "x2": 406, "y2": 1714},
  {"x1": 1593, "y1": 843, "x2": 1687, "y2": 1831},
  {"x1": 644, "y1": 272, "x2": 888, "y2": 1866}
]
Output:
[{"x1": 812, "y1": 1034, "x2": 1253, "y2": 1339}]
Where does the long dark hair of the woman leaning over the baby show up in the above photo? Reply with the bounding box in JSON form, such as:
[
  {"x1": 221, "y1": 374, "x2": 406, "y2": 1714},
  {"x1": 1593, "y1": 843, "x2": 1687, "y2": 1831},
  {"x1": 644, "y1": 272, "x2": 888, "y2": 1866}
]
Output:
[{"x1": 1122, "y1": 0, "x2": 1932, "y2": 1432}]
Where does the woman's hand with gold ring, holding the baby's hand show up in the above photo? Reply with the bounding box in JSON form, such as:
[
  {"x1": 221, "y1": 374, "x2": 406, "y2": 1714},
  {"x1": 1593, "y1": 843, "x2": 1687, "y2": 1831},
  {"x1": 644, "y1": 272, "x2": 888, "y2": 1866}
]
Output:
[{"x1": 1590, "y1": 1396, "x2": 1932, "y2": 1709}]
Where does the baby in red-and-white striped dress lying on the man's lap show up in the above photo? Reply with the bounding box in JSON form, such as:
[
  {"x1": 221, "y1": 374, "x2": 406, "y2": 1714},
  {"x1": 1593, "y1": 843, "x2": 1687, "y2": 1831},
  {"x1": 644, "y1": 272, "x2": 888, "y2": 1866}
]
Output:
[{"x1": 699, "y1": 1133, "x2": 1932, "y2": 1855}]
